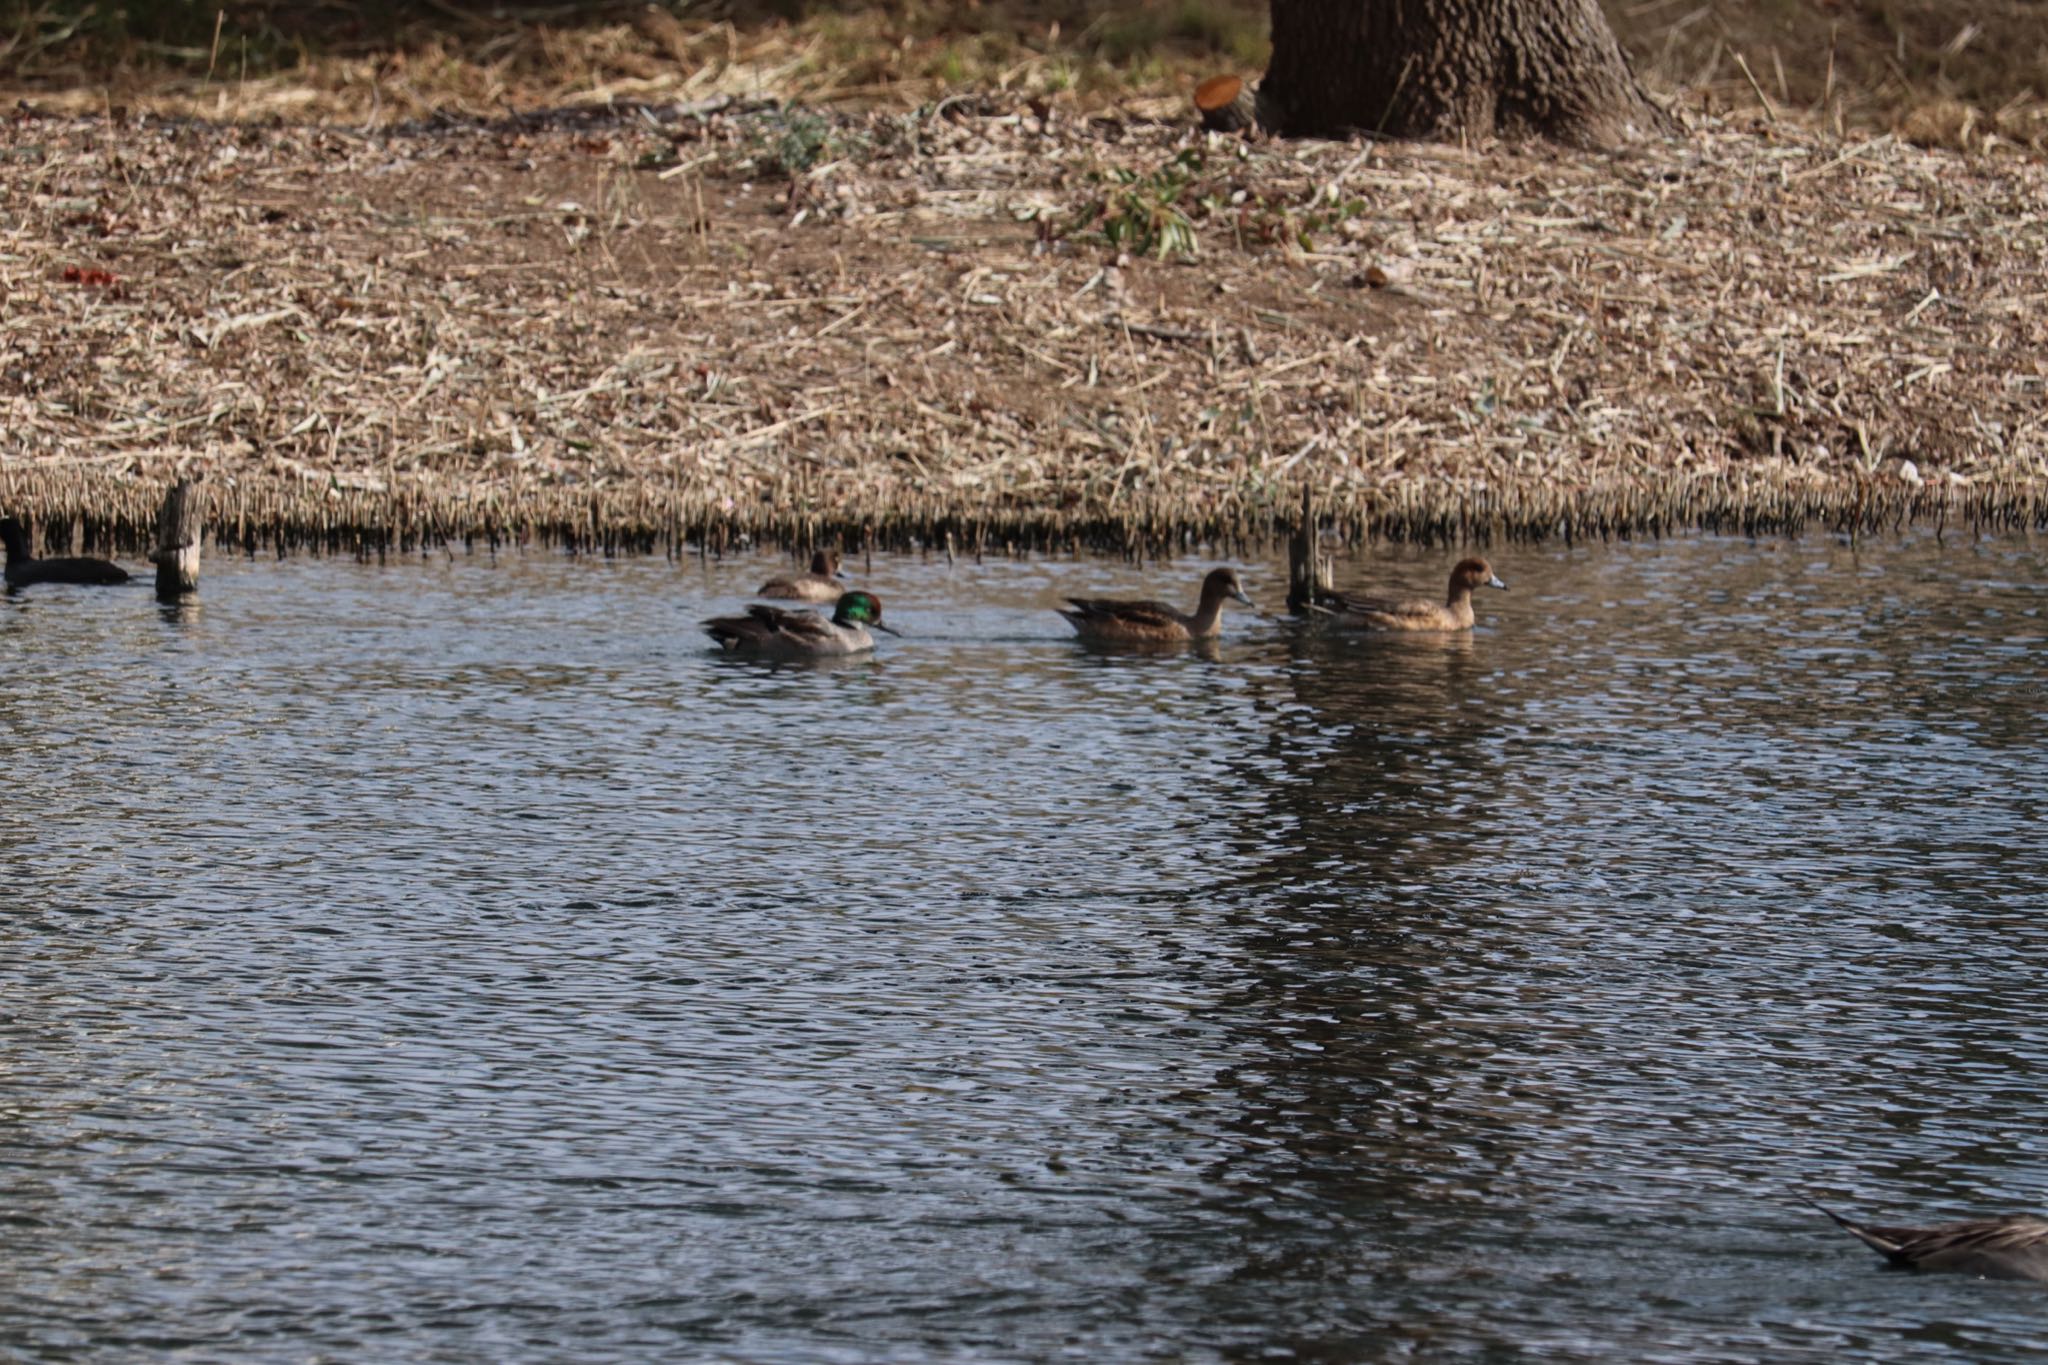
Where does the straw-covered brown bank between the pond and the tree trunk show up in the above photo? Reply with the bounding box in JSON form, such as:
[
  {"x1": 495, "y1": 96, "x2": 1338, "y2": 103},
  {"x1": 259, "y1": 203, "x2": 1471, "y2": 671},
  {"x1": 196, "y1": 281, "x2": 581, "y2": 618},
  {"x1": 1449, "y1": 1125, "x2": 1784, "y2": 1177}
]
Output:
[{"x1": 0, "y1": 96, "x2": 2048, "y2": 546}]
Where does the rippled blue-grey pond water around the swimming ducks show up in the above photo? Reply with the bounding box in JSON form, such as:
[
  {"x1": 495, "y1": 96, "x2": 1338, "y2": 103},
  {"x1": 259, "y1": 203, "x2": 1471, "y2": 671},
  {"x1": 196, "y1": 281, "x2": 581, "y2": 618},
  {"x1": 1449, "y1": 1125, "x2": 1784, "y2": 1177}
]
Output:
[{"x1": 0, "y1": 540, "x2": 2048, "y2": 1361}]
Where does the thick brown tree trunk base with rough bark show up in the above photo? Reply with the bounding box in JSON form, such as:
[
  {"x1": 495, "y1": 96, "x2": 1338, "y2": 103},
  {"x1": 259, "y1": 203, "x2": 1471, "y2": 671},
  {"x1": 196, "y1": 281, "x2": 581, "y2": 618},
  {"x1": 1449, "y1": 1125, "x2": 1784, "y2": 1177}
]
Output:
[{"x1": 1260, "y1": 0, "x2": 1667, "y2": 145}]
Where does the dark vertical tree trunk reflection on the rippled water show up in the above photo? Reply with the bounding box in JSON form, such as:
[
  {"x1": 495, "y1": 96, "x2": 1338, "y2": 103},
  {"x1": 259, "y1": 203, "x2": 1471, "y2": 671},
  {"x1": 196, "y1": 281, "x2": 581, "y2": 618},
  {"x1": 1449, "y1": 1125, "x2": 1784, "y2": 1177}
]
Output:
[{"x1": 1187, "y1": 626, "x2": 1520, "y2": 1359}]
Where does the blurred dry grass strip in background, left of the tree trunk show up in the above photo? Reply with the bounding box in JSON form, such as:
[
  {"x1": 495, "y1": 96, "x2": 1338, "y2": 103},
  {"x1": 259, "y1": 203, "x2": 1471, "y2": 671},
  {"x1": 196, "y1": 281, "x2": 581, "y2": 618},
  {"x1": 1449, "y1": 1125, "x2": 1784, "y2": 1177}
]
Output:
[{"x1": 0, "y1": 0, "x2": 1266, "y2": 127}]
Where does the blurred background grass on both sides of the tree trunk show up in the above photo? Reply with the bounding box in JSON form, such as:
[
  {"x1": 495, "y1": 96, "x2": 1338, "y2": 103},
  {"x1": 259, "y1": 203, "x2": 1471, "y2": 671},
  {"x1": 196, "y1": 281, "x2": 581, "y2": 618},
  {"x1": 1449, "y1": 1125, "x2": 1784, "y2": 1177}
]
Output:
[{"x1": 0, "y1": 0, "x2": 2048, "y2": 151}]
